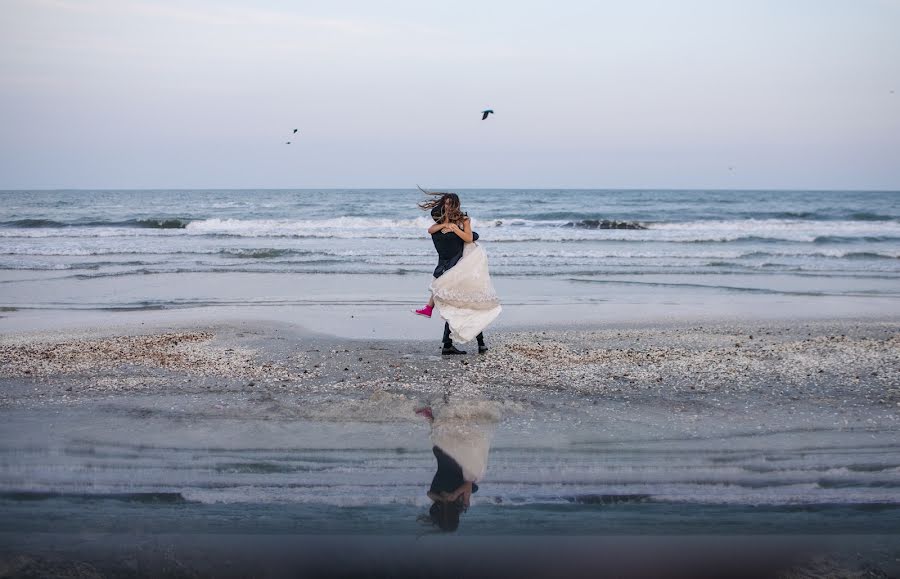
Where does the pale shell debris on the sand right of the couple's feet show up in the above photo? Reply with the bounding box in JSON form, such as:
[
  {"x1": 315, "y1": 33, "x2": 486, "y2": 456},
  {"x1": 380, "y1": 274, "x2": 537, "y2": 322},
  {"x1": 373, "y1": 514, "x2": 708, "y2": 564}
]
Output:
[{"x1": 462, "y1": 328, "x2": 900, "y2": 400}]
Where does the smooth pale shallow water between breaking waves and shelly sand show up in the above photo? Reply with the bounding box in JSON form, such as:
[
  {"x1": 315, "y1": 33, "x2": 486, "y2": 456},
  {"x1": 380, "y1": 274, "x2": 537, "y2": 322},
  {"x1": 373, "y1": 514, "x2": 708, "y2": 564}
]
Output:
[{"x1": 0, "y1": 271, "x2": 900, "y2": 340}]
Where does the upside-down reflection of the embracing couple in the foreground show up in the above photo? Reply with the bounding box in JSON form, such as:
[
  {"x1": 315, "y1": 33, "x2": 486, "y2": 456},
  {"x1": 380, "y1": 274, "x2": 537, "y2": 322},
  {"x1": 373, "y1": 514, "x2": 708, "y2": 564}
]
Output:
[{"x1": 416, "y1": 402, "x2": 499, "y2": 532}]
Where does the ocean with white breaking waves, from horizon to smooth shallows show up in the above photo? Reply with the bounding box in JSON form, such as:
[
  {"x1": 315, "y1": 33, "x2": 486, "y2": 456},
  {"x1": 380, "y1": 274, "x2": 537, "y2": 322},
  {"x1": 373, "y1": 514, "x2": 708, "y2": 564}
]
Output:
[{"x1": 0, "y1": 189, "x2": 900, "y2": 282}]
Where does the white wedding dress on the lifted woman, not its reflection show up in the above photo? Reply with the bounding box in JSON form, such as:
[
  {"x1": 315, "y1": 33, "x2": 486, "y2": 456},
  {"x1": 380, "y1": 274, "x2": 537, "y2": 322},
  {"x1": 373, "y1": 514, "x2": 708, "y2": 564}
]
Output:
[{"x1": 429, "y1": 243, "x2": 502, "y2": 343}]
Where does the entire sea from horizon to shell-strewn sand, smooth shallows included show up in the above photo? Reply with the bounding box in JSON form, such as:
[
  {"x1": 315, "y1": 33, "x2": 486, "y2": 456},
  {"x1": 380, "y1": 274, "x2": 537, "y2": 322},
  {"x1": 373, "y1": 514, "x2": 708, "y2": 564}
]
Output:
[{"x1": 0, "y1": 188, "x2": 900, "y2": 339}]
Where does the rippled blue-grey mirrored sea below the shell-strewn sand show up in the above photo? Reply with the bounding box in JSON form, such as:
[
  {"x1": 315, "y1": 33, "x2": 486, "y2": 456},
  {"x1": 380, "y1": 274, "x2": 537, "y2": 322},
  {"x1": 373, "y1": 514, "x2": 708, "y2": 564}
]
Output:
[{"x1": 0, "y1": 395, "x2": 900, "y2": 534}]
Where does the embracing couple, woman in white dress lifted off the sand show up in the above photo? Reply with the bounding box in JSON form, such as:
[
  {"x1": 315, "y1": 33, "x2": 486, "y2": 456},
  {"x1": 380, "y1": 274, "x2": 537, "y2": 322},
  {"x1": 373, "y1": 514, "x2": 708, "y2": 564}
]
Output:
[{"x1": 415, "y1": 190, "x2": 501, "y2": 355}]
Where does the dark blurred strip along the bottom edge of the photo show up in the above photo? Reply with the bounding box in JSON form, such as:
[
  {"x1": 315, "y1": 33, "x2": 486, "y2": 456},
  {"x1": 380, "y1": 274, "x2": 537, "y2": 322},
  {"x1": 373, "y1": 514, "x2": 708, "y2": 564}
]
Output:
[{"x1": 0, "y1": 534, "x2": 900, "y2": 579}]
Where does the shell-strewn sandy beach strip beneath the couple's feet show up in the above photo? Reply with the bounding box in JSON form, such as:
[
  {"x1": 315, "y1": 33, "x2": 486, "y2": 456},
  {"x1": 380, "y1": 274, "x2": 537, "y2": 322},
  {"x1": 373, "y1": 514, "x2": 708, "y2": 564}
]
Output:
[{"x1": 0, "y1": 320, "x2": 900, "y2": 420}]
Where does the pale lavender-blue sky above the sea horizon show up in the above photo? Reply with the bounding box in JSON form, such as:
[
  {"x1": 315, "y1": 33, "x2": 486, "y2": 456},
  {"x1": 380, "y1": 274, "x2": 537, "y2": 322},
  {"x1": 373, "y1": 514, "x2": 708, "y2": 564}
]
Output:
[{"x1": 0, "y1": 0, "x2": 900, "y2": 190}]
